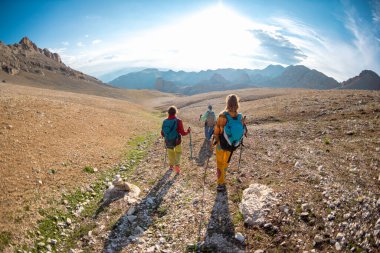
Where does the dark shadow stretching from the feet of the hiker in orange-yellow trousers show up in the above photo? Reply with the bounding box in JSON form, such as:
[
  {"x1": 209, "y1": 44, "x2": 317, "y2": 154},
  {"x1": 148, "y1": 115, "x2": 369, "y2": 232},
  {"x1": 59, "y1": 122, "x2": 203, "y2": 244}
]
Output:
[{"x1": 204, "y1": 187, "x2": 244, "y2": 252}]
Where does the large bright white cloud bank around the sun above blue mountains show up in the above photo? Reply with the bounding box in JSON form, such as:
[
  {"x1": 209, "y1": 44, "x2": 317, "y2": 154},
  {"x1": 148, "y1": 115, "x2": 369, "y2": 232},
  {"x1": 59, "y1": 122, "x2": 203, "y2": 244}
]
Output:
[{"x1": 62, "y1": 5, "x2": 380, "y2": 81}]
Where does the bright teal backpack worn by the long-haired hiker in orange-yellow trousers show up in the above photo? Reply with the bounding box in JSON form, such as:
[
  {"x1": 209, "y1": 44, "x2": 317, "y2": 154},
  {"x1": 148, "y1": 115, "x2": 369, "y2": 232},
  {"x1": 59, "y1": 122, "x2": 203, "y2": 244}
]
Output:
[{"x1": 220, "y1": 112, "x2": 244, "y2": 152}]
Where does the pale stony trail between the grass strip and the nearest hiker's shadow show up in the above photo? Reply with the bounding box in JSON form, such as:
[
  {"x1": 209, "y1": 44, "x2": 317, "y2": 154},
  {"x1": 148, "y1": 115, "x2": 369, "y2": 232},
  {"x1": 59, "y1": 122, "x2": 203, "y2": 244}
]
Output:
[{"x1": 86, "y1": 123, "x2": 245, "y2": 252}]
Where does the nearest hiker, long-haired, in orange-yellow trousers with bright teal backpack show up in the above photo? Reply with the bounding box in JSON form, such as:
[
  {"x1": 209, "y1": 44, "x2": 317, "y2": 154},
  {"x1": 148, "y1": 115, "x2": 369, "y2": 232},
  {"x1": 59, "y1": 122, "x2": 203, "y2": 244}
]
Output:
[{"x1": 213, "y1": 94, "x2": 247, "y2": 191}]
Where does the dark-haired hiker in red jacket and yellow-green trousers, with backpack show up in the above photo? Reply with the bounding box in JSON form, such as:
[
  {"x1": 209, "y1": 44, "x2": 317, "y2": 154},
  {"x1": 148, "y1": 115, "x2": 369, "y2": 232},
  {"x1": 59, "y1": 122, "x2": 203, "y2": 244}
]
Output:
[{"x1": 161, "y1": 106, "x2": 191, "y2": 173}]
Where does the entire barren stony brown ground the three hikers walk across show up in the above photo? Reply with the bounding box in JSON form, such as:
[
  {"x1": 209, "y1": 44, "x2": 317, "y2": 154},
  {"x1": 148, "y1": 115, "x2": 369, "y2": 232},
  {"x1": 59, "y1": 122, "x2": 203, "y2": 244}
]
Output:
[{"x1": 0, "y1": 84, "x2": 380, "y2": 252}]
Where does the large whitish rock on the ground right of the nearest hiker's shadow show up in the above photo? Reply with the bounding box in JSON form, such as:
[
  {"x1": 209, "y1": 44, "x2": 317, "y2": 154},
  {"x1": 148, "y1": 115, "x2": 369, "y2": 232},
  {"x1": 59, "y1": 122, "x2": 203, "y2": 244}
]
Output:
[{"x1": 240, "y1": 184, "x2": 277, "y2": 226}]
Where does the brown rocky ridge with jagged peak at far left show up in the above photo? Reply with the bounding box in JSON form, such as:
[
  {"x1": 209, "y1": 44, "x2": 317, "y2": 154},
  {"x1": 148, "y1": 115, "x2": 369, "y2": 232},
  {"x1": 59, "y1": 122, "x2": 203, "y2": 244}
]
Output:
[{"x1": 0, "y1": 37, "x2": 173, "y2": 102}]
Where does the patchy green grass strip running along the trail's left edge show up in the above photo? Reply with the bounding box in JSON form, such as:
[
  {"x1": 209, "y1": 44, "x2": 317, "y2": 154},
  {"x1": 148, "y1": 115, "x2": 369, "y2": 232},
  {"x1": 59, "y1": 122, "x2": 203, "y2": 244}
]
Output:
[{"x1": 18, "y1": 133, "x2": 157, "y2": 252}]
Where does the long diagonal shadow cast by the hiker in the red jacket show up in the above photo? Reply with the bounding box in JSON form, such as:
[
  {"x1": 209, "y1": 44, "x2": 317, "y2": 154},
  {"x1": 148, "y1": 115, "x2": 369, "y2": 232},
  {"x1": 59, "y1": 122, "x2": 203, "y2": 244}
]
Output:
[{"x1": 103, "y1": 170, "x2": 178, "y2": 252}]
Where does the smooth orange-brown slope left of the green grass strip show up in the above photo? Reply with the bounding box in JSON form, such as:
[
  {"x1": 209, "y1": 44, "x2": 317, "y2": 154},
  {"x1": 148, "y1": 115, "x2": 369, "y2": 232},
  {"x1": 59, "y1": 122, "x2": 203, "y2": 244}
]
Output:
[{"x1": 0, "y1": 83, "x2": 158, "y2": 251}]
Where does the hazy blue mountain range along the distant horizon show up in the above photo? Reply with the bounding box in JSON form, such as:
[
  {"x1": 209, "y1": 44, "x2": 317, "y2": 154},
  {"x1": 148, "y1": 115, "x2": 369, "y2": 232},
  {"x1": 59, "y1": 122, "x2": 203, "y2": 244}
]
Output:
[{"x1": 109, "y1": 65, "x2": 380, "y2": 95}]
